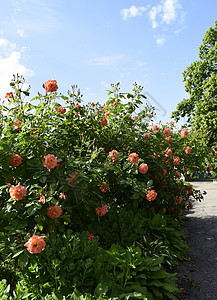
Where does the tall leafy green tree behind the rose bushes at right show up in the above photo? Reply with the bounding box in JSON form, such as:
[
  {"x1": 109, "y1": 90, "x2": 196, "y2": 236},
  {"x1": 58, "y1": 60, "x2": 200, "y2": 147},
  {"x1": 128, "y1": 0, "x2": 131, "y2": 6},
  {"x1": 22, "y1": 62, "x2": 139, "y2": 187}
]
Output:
[{"x1": 172, "y1": 21, "x2": 217, "y2": 145}]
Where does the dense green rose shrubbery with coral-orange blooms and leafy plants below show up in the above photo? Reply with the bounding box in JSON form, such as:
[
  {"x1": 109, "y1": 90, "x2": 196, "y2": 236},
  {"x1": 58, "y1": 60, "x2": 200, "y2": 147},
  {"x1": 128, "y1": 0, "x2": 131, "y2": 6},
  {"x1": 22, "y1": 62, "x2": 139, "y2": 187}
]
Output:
[{"x1": 0, "y1": 77, "x2": 209, "y2": 299}]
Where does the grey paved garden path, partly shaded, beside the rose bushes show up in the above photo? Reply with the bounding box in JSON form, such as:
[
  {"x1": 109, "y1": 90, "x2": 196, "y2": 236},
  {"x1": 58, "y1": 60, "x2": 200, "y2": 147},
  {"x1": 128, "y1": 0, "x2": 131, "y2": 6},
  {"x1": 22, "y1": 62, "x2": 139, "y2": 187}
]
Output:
[{"x1": 175, "y1": 182, "x2": 217, "y2": 300}]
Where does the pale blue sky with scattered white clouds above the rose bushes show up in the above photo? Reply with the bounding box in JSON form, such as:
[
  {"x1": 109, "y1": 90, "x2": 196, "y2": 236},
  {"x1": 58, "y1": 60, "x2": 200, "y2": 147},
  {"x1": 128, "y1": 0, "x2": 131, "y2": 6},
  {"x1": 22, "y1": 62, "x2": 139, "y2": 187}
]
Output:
[{"x1": 0, "y1": 0, "x2": 217, "y2": 122}]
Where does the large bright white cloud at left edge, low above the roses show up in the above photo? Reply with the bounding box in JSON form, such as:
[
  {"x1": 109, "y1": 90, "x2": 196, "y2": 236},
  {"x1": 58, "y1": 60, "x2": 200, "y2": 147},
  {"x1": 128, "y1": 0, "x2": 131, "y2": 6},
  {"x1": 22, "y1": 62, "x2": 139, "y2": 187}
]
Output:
[{"x1": 0, "y1": 39, "x2": 34, "y2": 99}]
